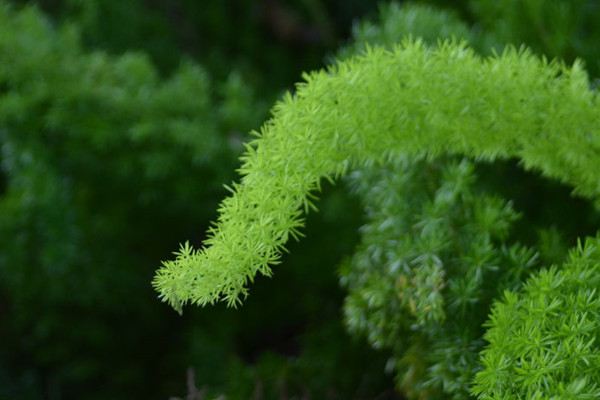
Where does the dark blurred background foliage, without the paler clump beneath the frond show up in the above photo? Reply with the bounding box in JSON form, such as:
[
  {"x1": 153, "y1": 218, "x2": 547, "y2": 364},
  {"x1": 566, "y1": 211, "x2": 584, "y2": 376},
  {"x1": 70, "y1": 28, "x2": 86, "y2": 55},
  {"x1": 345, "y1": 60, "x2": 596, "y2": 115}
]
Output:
[{"x1": 0, "y1": 0, "x2": 600, "y2": 400}]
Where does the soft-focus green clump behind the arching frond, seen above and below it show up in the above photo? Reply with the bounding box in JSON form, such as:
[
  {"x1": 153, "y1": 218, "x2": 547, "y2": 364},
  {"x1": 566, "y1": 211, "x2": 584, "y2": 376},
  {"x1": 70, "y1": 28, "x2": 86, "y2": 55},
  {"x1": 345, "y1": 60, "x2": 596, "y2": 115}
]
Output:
[{"x1": 332, "y1": 4, "x2": 594, "y2": 399}]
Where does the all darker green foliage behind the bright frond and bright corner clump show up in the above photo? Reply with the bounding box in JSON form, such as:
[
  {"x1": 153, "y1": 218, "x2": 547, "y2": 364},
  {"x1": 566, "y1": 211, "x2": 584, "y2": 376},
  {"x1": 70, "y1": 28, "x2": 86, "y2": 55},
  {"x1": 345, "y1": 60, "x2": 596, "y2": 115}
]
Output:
[{"x1": 0, "y1": 0, "x2": 600, "y2": 399}]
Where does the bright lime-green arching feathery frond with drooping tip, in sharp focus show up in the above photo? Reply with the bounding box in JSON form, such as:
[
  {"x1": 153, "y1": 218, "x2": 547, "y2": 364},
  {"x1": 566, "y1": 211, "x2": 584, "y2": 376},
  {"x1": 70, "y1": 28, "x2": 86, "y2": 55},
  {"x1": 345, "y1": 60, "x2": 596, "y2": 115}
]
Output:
[{"x1": 154, "y1": 42, "x2": 600, "y2": 308}]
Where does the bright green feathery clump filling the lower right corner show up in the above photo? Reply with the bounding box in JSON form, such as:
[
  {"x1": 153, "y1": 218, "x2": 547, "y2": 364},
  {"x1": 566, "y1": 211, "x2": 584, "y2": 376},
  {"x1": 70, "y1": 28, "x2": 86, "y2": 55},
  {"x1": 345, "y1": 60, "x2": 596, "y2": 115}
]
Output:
[{"x1": 473, "y1": 237, "x2": 600, "y2": 399}]
